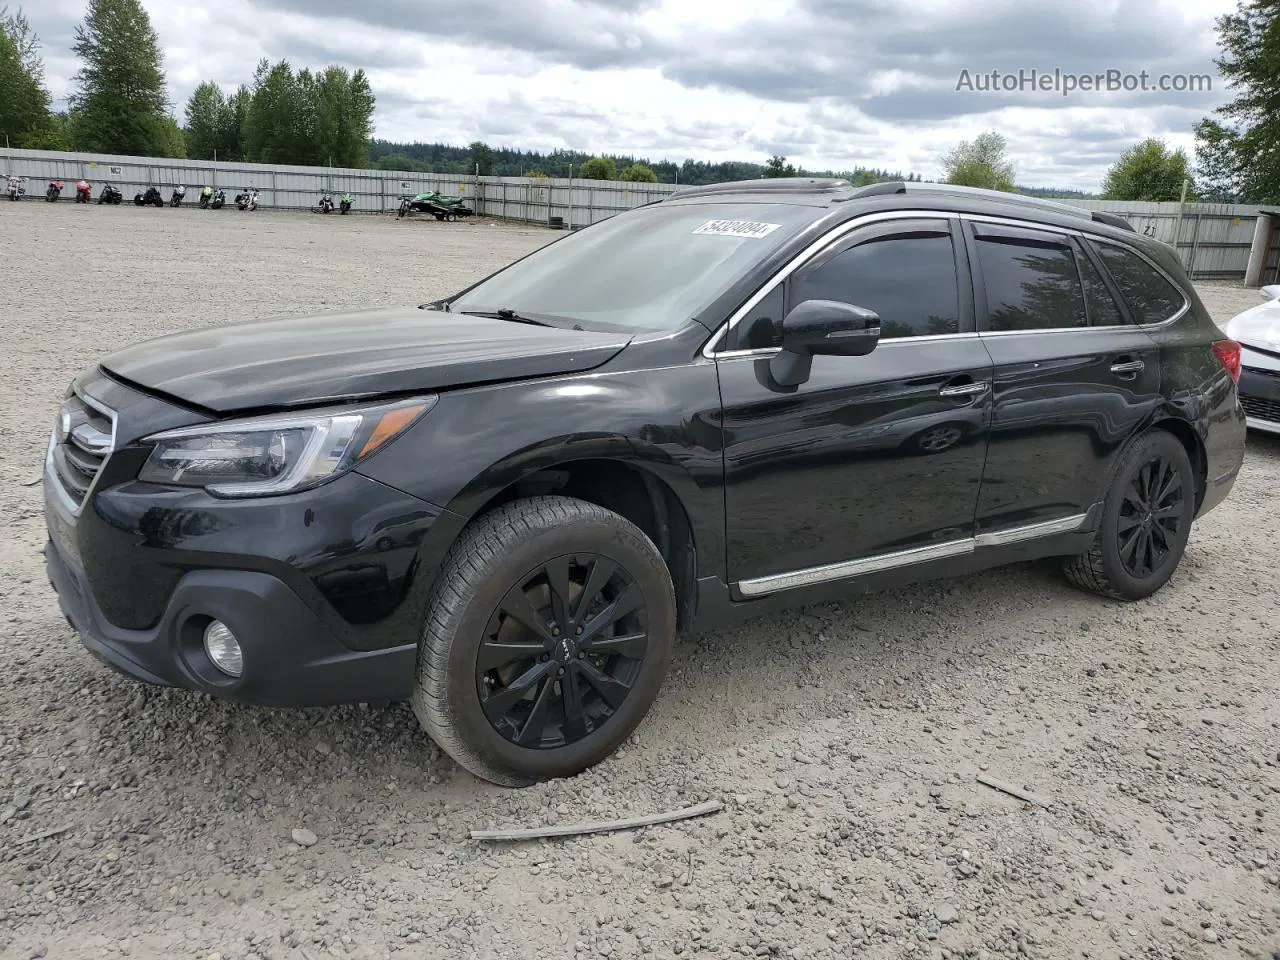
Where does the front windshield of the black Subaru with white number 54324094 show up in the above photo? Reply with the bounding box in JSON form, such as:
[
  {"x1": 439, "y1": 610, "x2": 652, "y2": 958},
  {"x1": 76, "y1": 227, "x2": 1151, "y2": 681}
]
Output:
[{"x1": 449, "y1": 201, "x2": 815, "y2": 329}]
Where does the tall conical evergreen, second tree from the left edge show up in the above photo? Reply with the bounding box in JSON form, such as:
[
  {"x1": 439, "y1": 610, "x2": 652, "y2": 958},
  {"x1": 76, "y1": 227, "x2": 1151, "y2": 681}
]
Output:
[{"x1": 70, "y1": 0, "x2": 182, "y2": 156}]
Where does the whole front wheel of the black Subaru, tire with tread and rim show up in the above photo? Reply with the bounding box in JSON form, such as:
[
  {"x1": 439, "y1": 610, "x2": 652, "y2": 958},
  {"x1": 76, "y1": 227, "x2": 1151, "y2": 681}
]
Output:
[{"x1": 412, "y1": 497, "x2": 676, "y2": 787}]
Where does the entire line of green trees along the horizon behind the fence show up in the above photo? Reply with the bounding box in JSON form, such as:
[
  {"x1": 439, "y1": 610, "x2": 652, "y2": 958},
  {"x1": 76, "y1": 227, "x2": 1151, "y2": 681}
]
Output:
[{"x1": 0, "y1": 0, "x2": 1280, "y2": 204}]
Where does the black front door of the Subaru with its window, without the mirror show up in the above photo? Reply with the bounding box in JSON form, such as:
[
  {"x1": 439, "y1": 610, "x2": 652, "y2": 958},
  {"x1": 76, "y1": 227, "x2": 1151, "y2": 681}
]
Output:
[{"x1": 717, "y1": 218, "x2": 992, "y2": 595}]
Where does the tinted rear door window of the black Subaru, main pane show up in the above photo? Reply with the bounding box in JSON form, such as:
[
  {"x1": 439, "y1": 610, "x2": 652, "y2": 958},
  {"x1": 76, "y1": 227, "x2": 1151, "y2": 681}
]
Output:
[{"x1": 977, "y1": 233, "x2": 1088, "y2": 330}]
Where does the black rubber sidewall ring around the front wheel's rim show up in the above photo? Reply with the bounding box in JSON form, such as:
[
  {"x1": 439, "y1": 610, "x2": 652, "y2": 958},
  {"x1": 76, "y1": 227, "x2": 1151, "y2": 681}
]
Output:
[{"x1": 424, "y1": 520, "x2": 676, "y2": 781}]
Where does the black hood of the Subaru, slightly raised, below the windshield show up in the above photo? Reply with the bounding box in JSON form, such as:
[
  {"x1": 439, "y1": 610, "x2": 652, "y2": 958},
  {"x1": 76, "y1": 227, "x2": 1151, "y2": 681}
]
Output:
[{"x1": 101, "y1": 307, "x2": 631, "y2": 413}]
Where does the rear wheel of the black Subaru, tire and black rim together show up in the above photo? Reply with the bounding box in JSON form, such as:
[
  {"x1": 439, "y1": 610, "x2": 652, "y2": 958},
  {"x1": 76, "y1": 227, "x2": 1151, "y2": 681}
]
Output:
[{"x1": 1064, "y1": 430, "x2": 1197, "y2": 600}]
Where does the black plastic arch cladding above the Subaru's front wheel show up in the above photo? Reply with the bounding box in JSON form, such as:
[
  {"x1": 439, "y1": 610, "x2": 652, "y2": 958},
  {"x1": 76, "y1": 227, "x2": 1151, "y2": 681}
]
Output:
[{"x1": 451, "y1": 456, "x2": 699, "y2": 630}]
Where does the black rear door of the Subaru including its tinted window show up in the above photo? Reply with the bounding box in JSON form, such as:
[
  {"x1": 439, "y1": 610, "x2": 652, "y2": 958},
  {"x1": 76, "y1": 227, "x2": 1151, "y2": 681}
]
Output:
[{"x1": 965, "y1": 218, "x2": 1161, "y2": 538}]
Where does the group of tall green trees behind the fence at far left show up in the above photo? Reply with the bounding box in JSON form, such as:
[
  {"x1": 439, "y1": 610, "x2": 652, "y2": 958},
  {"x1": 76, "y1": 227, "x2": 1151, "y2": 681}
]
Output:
[{"x1": 0, "y1": 0, "x2": 375, "y2": 166}]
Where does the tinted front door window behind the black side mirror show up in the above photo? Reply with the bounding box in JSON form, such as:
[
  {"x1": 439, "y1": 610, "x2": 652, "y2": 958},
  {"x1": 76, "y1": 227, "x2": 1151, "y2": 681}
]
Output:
[{"x1": 790, "y1": 225, "x2": 960, "y2": 339}]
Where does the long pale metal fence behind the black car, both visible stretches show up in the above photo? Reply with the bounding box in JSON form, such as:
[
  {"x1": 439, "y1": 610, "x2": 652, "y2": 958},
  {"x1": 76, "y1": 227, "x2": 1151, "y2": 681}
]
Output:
[{"x1": 0, "y1": 151, "x2": 1274, "y2": 278}]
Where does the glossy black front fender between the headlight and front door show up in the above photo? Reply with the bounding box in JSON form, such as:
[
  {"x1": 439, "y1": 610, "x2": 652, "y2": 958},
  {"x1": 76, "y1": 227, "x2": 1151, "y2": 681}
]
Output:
[{"x1": 358, "y1": 351, "x2": 724, "y2": 601}]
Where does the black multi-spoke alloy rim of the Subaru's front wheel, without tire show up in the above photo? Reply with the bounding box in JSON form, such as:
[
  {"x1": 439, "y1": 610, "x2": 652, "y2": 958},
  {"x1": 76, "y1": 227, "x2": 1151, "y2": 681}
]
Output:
[{"x1": 475, "y1": 553, "x2": 649, "y2": 750}]
